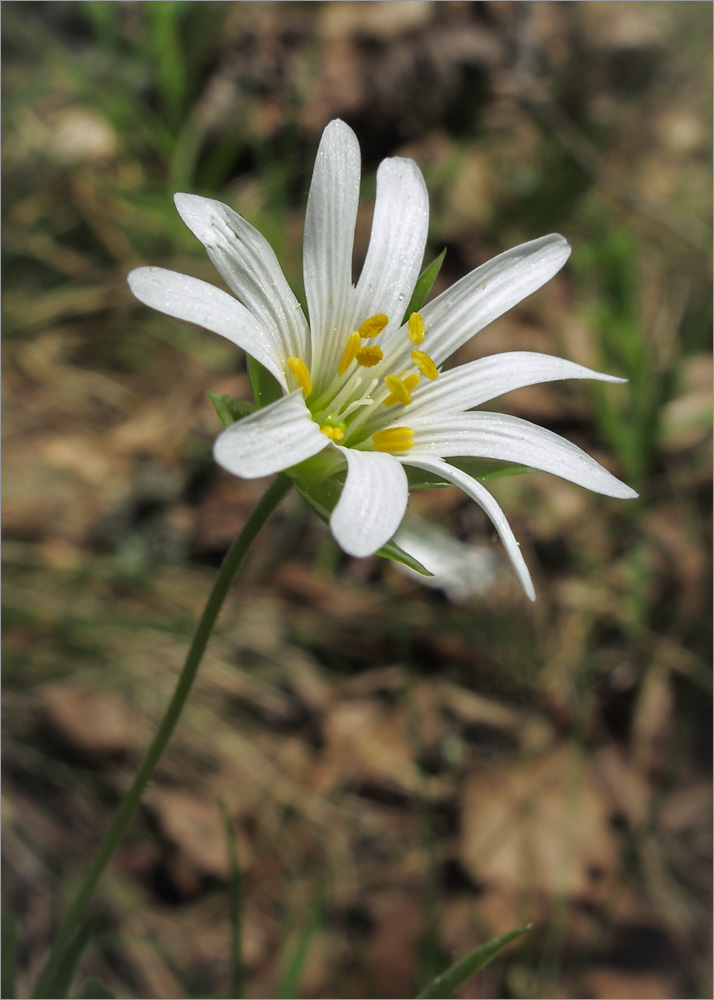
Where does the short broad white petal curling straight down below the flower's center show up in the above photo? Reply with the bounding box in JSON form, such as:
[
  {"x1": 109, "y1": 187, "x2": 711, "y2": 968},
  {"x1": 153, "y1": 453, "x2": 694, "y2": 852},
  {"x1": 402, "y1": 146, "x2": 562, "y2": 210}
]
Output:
[{"x1": 330, "y1": 448, "x2": 409, "y2": 556}]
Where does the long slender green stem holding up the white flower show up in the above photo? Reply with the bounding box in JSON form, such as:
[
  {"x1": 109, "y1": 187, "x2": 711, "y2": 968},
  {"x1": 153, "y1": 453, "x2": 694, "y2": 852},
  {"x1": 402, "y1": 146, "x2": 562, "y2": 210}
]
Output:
[{"x1": 32, "y1": 476, "x2": 292, "y2": 1000}]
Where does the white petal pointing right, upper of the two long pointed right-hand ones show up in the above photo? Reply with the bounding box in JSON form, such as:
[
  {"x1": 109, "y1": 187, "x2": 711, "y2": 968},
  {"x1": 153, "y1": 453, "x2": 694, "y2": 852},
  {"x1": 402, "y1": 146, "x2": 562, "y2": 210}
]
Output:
[{"x1": 409, "y1": 351, "x2": 627, "y2": 416}]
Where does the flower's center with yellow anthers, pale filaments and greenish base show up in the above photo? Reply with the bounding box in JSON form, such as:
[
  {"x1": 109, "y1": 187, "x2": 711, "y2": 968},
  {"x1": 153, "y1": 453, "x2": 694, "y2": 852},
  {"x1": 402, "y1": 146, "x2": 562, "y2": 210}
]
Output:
[{"x1": 287, "y1": 312, "x2": 439, "y2": 452}]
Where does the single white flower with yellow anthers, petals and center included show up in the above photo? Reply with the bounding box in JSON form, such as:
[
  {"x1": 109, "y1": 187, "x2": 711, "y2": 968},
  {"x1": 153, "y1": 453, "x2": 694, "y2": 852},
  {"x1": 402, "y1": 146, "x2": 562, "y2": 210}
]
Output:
[{"x1": 129, "y1": 120, "x2": 636, "y2": 599}]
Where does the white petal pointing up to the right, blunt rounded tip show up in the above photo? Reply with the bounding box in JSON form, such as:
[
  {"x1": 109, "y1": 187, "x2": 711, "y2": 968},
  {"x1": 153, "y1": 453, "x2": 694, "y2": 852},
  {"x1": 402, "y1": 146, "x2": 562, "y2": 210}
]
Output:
[{"x1": 421, "y1": 233, "x2": 570, "y2": 365}]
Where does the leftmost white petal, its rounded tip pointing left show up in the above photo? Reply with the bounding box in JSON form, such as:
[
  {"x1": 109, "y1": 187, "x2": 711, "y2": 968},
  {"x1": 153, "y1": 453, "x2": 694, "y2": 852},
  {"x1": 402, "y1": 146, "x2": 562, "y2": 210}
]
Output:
[{"x1": 127, "y1": 267, "x2": 285, "y2": 387}]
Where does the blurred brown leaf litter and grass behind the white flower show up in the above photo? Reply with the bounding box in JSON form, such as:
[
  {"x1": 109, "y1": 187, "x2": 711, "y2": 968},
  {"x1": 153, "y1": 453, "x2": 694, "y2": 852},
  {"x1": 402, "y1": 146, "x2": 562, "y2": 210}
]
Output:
[{"x1": 2, "y1": 0, "x2": 712, "y2": 998}]
